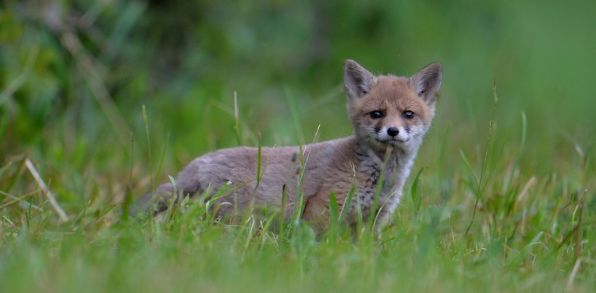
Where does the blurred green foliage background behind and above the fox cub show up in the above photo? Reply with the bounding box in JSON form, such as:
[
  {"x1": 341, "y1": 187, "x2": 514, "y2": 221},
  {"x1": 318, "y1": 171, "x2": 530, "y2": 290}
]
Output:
[{"x1": 0, "y1": 0, "x2": 596, "y2": 208}]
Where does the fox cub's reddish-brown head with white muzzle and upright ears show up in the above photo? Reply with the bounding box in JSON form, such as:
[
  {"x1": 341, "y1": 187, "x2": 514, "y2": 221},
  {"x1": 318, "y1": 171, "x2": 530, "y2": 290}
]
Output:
[{"x1": 344, "y1": 60, "x2": 443, "y2": 152}]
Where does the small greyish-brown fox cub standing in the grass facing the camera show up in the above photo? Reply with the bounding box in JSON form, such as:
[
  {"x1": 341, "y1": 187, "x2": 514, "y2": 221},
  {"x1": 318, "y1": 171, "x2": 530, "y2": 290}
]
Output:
[{"x1": 135, "y1": 60, "x2": 442, "y2": 232}]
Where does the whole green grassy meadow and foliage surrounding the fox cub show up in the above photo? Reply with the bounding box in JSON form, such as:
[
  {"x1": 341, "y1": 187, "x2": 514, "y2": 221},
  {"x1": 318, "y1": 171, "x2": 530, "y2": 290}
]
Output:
[{"x1": 0, "y1": 0, "x2": 596, "y2": 292}]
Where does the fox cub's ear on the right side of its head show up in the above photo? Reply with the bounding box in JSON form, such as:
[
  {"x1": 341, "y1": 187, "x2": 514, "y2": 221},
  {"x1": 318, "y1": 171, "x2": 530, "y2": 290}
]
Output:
[{"x1": 410, "y1": 63, "x2": 443, "y2": 104}]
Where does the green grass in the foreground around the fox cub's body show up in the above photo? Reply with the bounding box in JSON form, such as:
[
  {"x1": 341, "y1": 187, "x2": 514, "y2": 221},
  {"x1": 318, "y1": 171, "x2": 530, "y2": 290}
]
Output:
[{"x1": 0, "y1": 93, "x2": 596, "y2": 292}]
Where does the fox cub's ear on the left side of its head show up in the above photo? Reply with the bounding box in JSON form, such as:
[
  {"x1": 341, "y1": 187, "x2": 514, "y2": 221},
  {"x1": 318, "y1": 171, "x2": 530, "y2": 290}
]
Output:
[{"x1": 344, "y1": 59, "x2": 376, "y2": 99}]
